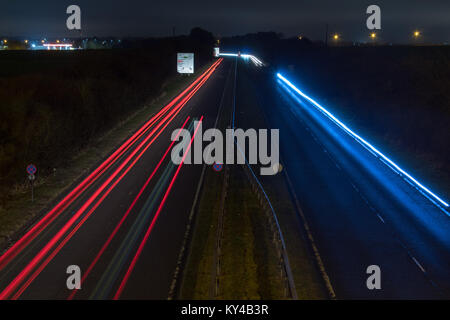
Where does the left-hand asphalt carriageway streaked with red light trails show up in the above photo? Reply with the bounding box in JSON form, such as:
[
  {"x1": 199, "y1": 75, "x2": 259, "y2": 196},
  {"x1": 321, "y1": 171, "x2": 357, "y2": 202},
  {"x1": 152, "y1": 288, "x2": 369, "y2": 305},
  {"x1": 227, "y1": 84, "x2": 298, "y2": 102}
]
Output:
[{"x1": 0, "y1": 57, "x2": 232, "y2": 299}]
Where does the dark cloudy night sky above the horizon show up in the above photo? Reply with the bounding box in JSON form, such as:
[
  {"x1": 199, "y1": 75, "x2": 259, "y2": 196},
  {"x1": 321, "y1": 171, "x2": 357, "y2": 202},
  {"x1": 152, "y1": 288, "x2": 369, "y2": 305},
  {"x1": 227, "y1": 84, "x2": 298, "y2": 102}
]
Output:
[{"x1": 0, "y1": 0, "x2": 450, "y2": 42}]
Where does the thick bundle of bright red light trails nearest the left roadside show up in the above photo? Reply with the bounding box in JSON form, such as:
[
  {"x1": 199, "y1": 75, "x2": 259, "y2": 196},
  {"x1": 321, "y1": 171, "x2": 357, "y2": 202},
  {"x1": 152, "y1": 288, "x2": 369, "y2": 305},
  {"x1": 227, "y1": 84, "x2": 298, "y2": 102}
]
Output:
[{"x1": 0, "y1": 60, "x2": 222, "y2": 299}]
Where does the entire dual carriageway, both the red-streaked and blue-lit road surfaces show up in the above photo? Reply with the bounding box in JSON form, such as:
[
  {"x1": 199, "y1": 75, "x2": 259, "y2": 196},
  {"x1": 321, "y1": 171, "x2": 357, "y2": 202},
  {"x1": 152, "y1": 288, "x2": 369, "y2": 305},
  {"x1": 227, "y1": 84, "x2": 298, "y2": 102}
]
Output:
[{"x1": 0, "y1": 53, "x2": 450, "y2": 299}]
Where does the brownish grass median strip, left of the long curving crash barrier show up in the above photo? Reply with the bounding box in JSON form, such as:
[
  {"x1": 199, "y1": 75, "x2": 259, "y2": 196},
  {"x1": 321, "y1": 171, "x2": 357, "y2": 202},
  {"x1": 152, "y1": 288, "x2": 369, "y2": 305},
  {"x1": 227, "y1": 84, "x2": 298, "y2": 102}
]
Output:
[{"x1": 180, "y1": 166, "x2": 285, "y2": 300}]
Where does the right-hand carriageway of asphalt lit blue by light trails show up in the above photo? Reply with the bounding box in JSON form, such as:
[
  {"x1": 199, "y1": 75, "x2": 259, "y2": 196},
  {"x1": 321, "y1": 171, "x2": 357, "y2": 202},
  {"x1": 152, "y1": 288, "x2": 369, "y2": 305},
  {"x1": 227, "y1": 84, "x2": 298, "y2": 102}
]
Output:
[{"x1": 236, "y1": 64, "x2": 450, "y2": 299}]
